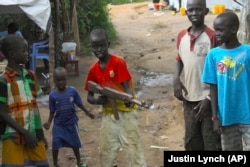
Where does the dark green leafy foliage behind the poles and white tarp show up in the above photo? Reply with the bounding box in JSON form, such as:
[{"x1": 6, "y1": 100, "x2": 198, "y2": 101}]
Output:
[{"x1": 0, "y1": 0, "x2": 145, "y2": 53}]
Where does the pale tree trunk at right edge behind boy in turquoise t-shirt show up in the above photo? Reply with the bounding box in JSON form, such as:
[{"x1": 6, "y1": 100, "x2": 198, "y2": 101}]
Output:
[{"x1": 238, "y1": 0, "x2": 250, "y2": 44}]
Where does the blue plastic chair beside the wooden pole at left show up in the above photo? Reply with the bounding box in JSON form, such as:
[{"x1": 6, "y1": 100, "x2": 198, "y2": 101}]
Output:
[{"x1": 29, "y1": 40, "x2": 49, "y2": 72}]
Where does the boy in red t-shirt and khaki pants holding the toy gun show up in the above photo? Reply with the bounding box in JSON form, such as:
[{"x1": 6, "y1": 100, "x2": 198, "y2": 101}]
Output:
[{"x1": 85, "y1": 29, "x2": 146, "y2": 167}]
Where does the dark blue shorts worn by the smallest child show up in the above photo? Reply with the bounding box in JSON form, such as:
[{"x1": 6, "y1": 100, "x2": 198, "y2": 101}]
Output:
[{"x1": 52, "y1": 124, "x2": 81, "y2": 150}]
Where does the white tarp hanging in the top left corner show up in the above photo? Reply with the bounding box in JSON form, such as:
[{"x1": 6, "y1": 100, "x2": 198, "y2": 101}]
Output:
[{"x1": 0, "y1": 0, "x2": 52, "y2": 32}]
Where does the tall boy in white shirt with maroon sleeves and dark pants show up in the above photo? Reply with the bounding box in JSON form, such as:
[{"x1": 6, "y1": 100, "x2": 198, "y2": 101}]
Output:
[{"x1": 173, "y1": 0, "x2": 221, "y2": 151}]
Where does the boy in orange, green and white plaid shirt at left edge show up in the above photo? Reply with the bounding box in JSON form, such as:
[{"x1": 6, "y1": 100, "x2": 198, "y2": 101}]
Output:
[{"x1": 0, "y1": 35, "x2": 49, "y2": 167}]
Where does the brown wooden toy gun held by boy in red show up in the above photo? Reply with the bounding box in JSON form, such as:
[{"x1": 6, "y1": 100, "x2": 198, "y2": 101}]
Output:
[{"x1": 88, "y1": 81, "x2": 147, "y2": 120}]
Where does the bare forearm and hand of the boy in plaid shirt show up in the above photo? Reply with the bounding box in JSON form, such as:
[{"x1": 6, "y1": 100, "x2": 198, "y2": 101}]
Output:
[{"x1": 0, "y1": 102, "x2": 38, "y2": 149}]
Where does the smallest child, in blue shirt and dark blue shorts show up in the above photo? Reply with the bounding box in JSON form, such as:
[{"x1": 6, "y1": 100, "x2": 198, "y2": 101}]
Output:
[{"x1": 44, "y1": 67, "x2": 95, "y2": 167}]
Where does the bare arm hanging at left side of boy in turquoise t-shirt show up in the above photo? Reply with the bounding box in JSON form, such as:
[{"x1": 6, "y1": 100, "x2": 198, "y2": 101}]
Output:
[{"x1": 210, "y1": 84, "x2": 222, "y2": 134}]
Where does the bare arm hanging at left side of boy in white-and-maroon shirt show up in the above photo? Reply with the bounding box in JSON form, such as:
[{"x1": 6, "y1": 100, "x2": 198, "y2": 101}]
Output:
[{"x1": 173, "y1": 60, "x2": 188, "y2": 101}]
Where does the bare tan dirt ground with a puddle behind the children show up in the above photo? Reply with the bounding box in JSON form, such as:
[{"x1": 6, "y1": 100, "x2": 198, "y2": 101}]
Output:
[{"x1": 37, "y1": 1, "x2": 219, "y2": 167}]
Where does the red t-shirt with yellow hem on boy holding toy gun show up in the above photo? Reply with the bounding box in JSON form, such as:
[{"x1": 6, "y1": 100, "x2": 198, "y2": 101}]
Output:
[{"x1": 84, "y1": 54, "x2": 134, "y2": 112}]
